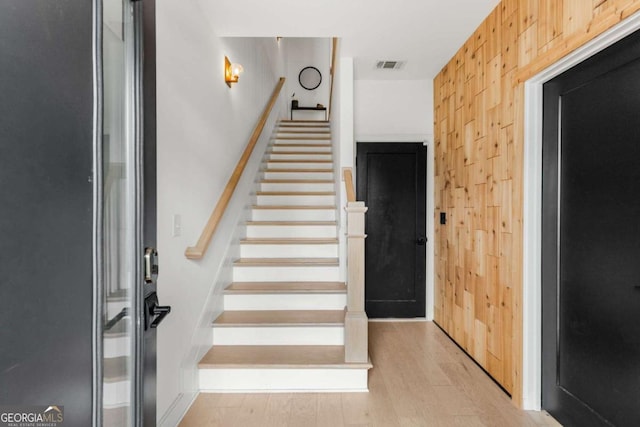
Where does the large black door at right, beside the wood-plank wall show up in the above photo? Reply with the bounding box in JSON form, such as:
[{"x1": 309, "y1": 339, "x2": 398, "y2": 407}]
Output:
[{"x1": 542, "y1": 28, "x2": 640, "y2": 427}]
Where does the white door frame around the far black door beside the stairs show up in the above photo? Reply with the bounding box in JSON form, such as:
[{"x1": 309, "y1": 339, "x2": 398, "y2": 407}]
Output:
[{"x1": 353, "y1": 135, "x2": 435, "y2": 322}]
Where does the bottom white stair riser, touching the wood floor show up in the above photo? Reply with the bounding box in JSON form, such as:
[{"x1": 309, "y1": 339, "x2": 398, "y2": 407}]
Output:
[{"x1": 199, "y1": 368, "x2": 368, "y2": 393}]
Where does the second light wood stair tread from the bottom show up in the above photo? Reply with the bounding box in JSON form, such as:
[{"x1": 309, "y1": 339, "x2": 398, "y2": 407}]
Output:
[{"x1": 213, "y1": 310, "x2": 344, "y2": 327}]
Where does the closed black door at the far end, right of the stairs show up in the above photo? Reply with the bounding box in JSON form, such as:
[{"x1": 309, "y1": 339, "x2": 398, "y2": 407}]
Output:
[{"x1": 356, "y1": 143, "x2": 427, "y2": 318}]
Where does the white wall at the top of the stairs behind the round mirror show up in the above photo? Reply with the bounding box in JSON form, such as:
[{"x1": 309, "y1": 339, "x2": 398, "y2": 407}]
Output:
[{"x1": 288, "y1": 37, "x2": 331, "y2": 120}]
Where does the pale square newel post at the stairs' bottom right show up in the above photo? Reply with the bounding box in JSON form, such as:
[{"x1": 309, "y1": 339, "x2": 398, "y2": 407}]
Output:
[{"x1": 344, "y1": 202, "x2": 369, "y2": 363}]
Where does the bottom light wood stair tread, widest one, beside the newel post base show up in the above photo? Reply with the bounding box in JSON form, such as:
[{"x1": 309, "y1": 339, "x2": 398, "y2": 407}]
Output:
[{"x1": 198, "y1": 345, "x2": 371, "y2": 369}]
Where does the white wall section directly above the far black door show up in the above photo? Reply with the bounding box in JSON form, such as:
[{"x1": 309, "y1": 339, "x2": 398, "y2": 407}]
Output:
[{"x1": 354, "y1": 79, "x2": 433, "y2": 140}]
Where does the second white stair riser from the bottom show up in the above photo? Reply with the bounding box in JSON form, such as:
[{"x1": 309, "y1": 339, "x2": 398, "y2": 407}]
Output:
[{"x1": 213, "y1": 326, "x2": 344, "y2": 345}]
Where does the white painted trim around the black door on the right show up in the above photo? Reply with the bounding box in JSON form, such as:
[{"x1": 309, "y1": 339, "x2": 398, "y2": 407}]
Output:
[{"x1": 522, "y1": 12, "x2": 640, "y2": 410}]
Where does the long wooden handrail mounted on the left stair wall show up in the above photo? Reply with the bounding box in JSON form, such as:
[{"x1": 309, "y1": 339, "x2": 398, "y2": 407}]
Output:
[{"x1": 184, "y1": 77, "x2": 285, "y2": 259}]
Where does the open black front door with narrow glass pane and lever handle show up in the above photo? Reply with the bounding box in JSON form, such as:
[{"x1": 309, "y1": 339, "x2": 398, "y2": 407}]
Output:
[{"x1": 0, "y1": 0, "x2": 166, "y2": 427}]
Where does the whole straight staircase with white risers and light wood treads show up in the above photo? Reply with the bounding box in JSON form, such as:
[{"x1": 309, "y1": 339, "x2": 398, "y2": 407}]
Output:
[{"x1": 199, "y1": 121, "x2": 371, "y2": 392}]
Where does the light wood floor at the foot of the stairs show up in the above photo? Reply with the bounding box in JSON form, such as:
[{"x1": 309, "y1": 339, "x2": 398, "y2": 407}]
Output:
[{"x1": 180, "y1": 322, "x2": 559, "y2": 427}]
